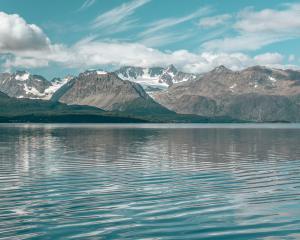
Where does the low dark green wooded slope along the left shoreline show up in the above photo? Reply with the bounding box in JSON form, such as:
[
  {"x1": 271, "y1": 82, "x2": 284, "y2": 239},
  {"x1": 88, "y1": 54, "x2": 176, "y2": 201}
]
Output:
[{"x1": 0, "y1": 92, "x2": 145, "y2": 123}]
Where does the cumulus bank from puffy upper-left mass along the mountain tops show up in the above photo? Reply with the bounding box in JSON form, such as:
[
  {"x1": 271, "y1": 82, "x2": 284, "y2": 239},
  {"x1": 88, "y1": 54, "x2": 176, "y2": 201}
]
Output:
[{"x1": 0, "y1": 13, "x2": 298, "y2": 73}]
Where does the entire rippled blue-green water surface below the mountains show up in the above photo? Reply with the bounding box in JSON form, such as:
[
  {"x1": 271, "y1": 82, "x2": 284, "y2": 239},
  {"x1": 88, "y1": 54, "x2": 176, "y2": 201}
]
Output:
[{"x1": 0, "y1": 124, "x2": 300, "y2": 240}]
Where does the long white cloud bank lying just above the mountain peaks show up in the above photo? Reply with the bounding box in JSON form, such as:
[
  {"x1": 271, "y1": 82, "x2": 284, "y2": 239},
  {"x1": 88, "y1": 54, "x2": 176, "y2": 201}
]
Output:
[{"x1": 54, "y1": 40, "x2": 285, "y2": 73}]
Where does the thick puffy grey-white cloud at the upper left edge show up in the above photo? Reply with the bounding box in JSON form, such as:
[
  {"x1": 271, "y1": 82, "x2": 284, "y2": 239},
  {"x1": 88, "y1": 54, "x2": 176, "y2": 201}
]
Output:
[{"x1": 0, "y1": 12, "x2": 50, "y2": 53}]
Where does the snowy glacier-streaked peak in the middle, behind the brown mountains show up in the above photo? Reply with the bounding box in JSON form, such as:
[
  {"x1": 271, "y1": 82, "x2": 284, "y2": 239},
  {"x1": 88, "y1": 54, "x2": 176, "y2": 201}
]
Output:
[{"x1": 115, "y1": 65, "x2": 197, "y2": 92}]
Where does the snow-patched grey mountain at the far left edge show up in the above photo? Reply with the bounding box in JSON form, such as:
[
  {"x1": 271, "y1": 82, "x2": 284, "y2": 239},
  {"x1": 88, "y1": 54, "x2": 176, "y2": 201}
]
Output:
[{"x1": 0, "y1": 71, "x2": 72, "y2": 100}]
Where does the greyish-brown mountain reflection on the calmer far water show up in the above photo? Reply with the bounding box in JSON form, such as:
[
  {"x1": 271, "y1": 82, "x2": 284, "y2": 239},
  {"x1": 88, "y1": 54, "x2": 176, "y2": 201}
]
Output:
[{"x1": 0, "y1": 125, "x2": 300, "y2": 175}]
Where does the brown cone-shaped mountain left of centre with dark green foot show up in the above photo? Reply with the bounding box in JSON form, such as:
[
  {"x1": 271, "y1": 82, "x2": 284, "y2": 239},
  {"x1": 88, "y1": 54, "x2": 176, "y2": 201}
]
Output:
[{"x1": 52, "y1": 70, "x2": 171, "y2": 114}]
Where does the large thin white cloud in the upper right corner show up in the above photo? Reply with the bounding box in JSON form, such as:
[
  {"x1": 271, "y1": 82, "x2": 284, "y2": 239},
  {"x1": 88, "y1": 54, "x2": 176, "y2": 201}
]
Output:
[{"x1": 202, "y1": 4, "x2": 300, "y2": 52}]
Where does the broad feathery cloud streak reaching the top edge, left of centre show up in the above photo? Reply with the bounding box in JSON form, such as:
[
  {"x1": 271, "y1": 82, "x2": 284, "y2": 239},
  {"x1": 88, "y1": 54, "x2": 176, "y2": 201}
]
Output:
[{"x1": 92, "y1": 0, "x2": 150, "y2": 32}]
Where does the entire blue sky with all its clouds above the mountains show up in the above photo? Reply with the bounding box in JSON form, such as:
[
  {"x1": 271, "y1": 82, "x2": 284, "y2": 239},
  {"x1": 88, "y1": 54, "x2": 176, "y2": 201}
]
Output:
[{"x1": 0, "y1": 0, "x2": 300, "y2": 78}]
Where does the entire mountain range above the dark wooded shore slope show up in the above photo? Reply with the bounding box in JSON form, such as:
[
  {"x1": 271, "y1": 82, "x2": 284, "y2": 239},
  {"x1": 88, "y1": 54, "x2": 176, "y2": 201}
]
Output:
[{"x1": 0, "y1": 65, "x2": 300, "y2": 122}]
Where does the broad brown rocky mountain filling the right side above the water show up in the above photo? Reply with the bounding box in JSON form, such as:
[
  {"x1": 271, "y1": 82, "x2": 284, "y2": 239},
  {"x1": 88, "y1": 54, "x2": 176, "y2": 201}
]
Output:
[{"x1": 154, "y1": 66, "x2": 300, "y2": 122}]
